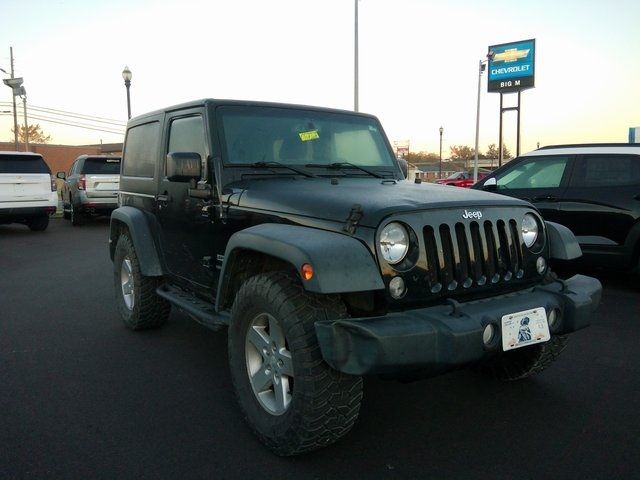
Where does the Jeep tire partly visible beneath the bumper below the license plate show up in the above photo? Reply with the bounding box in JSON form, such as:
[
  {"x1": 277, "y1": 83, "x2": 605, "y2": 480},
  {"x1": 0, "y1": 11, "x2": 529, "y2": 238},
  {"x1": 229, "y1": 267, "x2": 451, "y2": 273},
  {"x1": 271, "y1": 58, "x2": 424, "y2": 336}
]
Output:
[{"x1": 478, "y1": 335, "x2": 568, "y2": 381}]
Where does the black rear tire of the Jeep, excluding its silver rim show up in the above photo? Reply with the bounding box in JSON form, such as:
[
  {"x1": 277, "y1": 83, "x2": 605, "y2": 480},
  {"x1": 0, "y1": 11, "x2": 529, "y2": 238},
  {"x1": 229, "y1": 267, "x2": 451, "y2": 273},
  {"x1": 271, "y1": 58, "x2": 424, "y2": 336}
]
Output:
[{"x1": 113, "y1": 233, "x2": 171, "y2": 330}]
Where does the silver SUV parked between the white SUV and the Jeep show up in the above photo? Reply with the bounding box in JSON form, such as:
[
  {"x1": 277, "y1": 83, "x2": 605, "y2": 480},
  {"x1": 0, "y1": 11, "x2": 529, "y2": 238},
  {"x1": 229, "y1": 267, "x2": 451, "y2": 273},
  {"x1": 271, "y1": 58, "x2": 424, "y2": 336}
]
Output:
[{"x1": 57, "y1": 155, "x2": 121, "y2": 226}]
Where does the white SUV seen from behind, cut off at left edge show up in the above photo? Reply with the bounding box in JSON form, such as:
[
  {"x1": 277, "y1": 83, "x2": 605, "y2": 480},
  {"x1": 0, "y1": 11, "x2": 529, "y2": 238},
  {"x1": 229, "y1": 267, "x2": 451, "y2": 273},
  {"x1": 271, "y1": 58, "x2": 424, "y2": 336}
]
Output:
[{"x1": 0, "y1": 152, "x2": 58, "y2": 231}]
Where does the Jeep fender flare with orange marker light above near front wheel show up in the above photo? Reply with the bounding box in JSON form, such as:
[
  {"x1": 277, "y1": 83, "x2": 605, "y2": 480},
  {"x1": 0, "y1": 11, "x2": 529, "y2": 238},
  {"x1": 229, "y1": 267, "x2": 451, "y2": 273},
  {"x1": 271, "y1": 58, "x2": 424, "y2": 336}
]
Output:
[{"x1": 216, "y1": 223, "x2": 384, "y2": 309}]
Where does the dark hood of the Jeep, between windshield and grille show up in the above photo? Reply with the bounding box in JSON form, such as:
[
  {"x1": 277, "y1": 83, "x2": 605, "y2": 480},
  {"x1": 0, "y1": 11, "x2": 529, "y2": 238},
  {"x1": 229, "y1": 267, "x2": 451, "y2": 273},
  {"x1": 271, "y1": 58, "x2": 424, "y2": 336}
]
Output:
[{"x1": 230, "y1": 176, "x2": 530, "y2": 228}]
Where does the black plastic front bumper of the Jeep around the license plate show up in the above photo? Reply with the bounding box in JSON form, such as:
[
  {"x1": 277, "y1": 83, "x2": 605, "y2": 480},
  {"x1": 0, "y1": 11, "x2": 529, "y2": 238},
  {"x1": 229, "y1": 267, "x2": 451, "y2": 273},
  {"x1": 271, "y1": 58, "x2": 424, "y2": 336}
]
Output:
[{"x1": 315, "y1": 275, "x2": 602, "y2": 375}]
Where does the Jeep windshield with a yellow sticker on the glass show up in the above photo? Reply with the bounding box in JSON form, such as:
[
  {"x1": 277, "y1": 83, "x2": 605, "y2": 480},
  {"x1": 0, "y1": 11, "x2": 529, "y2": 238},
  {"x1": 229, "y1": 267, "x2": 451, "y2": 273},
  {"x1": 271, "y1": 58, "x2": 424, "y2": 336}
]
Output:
[{"x1": 218, "y1": 106, "x2": 397, "y2": 176}]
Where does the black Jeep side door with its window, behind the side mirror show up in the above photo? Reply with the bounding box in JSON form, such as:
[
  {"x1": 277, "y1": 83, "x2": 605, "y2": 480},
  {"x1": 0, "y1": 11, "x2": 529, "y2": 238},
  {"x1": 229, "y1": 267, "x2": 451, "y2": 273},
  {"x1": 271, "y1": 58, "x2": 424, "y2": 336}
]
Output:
[{"x1": 157, "y1": 109, "x2": 218, "y2": 291}]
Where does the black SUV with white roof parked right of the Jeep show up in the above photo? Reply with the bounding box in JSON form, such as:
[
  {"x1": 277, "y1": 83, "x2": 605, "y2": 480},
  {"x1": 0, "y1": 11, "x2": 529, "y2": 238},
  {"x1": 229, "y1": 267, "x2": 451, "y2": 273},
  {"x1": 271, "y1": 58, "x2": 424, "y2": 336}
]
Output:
[{"x1": 473, "y1": 143, "x2": 640, "y2": 270}]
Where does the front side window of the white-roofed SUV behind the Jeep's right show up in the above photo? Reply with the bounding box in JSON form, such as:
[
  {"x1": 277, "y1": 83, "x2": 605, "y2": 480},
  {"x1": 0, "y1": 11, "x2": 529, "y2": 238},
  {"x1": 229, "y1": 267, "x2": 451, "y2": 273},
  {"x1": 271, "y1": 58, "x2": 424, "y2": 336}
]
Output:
[{"x1": 497, "y1": 156, "x2": 569, "y2": 190}]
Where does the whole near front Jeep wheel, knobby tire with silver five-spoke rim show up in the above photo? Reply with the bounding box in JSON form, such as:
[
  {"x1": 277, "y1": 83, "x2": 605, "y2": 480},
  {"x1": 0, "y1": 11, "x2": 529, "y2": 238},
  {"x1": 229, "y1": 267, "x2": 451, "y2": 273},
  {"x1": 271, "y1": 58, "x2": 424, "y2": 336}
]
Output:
[{"x1": 228, "y1": 272, "x2": 362, "y2": 455}]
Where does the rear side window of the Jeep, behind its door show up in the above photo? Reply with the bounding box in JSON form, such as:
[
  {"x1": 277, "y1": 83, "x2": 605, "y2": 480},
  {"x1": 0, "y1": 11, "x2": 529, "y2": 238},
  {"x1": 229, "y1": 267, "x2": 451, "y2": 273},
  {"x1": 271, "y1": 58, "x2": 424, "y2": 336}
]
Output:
[{"x1": 122, "y1": 122, "x2": 160, "y2": 178}]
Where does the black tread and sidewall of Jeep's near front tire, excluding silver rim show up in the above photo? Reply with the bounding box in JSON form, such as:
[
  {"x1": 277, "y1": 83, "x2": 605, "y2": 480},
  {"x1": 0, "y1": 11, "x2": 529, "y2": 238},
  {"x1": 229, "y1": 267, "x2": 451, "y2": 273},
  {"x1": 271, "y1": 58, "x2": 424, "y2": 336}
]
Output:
[{"x1": 228, "y1": 272, "x2": 362, "y2": 456}]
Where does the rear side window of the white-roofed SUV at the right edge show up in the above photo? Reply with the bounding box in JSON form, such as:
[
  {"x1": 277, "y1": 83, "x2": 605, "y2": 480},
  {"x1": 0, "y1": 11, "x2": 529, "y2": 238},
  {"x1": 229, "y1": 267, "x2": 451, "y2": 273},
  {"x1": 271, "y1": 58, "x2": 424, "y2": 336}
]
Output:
[{"x1": 571, "y1": 155, "x2": 640, "y2": 187}]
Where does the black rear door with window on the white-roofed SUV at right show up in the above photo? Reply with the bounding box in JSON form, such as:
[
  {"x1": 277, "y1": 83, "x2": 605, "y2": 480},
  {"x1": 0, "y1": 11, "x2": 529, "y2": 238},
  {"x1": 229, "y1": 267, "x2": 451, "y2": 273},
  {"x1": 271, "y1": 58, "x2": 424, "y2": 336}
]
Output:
[{"x1": 559, "y1": 154, "x2": 640, "y2": 253}]
